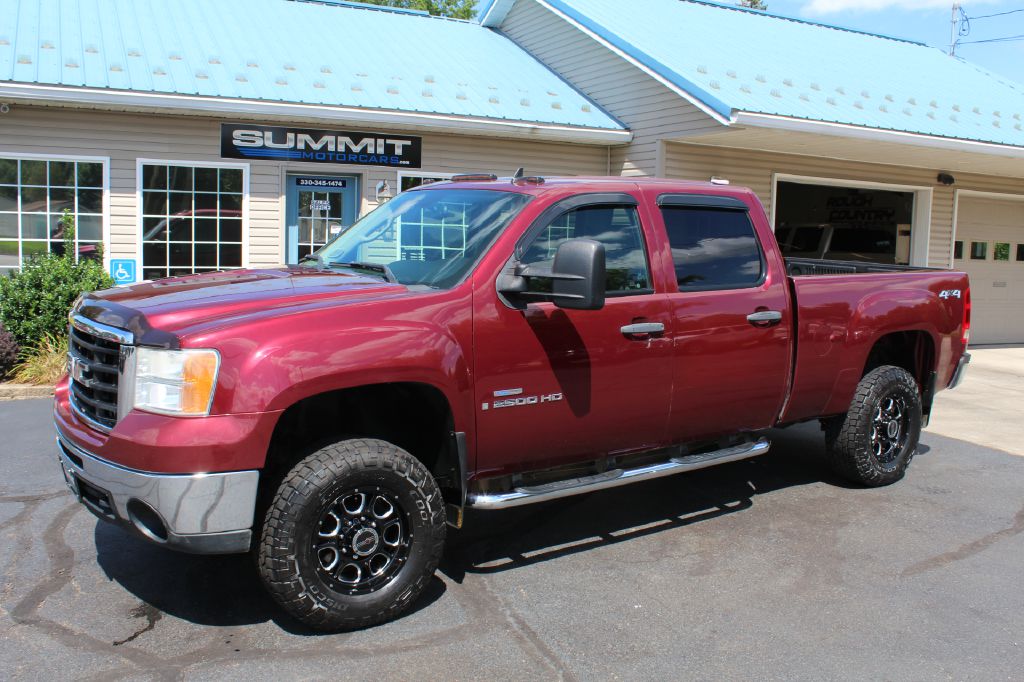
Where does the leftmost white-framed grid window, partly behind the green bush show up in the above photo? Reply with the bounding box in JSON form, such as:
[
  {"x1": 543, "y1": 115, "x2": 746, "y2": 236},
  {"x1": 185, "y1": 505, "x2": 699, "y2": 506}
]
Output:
[{"x1": 0, "y1": 158, "x2": 103, "y2": 275}]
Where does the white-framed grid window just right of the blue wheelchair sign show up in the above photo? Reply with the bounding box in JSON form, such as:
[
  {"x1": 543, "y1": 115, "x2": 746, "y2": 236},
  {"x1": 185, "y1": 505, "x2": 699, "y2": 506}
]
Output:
[{"x1": 140, "y1": 163, "x2": 245, "y2": 280}]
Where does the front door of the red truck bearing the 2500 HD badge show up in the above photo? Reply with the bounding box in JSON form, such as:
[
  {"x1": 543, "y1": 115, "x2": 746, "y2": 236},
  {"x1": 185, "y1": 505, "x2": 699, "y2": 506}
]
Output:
[{"x1": 473, "y1": 194, "x2": 672, "y2": 475}]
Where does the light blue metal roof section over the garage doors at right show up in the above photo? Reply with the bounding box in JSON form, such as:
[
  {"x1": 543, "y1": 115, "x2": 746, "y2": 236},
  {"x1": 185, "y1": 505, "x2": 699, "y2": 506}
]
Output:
[{"x1": 546, "y1": 0, "x2": 1024, "y2": 146}]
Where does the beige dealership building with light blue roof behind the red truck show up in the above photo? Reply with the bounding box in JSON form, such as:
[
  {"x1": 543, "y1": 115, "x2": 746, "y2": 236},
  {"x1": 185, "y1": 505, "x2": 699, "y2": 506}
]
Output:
[{"x1": 0, "y1": 0, "x2": 1024, "y2": 343}]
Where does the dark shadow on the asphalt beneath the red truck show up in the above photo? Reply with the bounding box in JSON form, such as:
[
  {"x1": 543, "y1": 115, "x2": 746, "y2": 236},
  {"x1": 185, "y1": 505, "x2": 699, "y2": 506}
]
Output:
[{"x1": 88, "y1": 424, "x2": 927, "y2": 635}]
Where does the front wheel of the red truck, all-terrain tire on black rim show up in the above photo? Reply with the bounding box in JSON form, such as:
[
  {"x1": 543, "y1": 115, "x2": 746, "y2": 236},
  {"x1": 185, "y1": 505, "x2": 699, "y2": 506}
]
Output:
[{"x1": 257, "y1": 438, "x2": 445, "y2": 631}]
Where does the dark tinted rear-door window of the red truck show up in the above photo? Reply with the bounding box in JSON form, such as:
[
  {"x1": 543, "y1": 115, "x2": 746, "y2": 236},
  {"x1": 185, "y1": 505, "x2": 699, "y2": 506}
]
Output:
[{"x1": 662, "y1": 206, "x2": 764, "y2": 284}]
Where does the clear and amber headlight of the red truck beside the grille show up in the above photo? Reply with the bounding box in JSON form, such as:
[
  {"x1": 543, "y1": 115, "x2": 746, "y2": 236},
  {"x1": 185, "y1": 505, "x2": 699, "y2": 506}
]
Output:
[{"x1": 134, "y1": 346, "x2": 220, "y2": 417}]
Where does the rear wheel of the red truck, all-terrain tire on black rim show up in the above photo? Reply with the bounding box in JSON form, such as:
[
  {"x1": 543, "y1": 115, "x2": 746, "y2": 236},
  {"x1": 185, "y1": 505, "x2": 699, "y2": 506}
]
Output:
[{"x1": 825, "y1": 366, "x2": 922, "y2": 487}]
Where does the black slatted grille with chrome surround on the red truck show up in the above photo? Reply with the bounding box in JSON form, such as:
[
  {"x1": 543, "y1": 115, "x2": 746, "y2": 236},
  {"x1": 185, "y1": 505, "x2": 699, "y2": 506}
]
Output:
[{"x1": 68, "y1": 319, "x2": 121, "y2": 429}]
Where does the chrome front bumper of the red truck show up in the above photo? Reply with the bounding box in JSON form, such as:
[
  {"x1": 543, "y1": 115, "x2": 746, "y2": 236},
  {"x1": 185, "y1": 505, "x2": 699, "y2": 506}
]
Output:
[{"x1": 57, "y1": 431, "x2": 259, "y2": 554}]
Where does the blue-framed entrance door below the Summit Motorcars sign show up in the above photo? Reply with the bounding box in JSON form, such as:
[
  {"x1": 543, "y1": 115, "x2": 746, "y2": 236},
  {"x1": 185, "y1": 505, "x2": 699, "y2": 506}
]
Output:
[{"x1": 286, "y1": 175, "x2": 358, "y2": 265}]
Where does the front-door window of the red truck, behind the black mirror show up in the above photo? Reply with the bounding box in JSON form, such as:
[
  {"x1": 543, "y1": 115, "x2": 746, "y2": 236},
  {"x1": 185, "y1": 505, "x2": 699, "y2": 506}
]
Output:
[{"x1": 521, "y1": 205, "x2": 650, "y2": 295}]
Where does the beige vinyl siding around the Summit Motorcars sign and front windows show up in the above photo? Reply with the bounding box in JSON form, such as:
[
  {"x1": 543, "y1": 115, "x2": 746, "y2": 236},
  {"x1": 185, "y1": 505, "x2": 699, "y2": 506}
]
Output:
[{"x1": 0, "y1": 104, "x2": 607, "y2": 266}]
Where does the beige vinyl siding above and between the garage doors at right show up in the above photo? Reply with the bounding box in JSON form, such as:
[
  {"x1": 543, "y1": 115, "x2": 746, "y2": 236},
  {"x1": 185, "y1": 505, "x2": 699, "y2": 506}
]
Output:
[{"x1": 666, "y1": 142, "x2": 1024, "y2": 267}]
